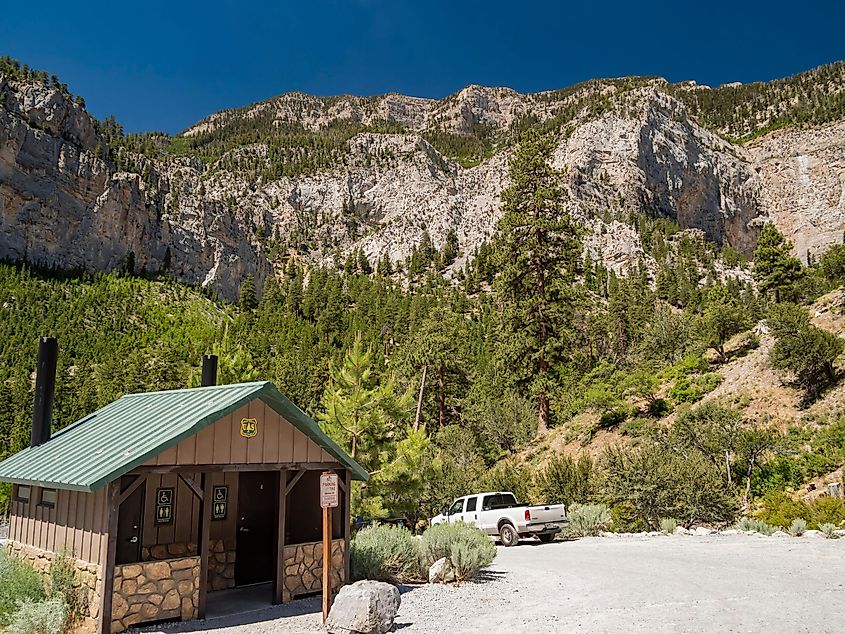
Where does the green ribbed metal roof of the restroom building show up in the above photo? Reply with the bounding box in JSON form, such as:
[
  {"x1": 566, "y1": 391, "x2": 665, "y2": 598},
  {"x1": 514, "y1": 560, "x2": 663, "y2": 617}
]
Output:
[{"x1": 0, "y1": 381, "x2": 369, "y2": 491}]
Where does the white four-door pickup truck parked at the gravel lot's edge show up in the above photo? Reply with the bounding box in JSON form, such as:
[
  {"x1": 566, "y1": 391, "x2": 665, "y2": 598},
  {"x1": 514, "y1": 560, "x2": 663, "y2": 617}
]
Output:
[{"x1": 431, "y1": 491, "x2": 569, "y2": 546}]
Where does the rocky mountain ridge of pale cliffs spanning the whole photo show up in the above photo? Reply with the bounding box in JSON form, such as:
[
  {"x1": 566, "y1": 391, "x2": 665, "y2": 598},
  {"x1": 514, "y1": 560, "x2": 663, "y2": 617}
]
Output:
[{"x1": 0, "y1": 60, "x2": 845, "y2": 298}]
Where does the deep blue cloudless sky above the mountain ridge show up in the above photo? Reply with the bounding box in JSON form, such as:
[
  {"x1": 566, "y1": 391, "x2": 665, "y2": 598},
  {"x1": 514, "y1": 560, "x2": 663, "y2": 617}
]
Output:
[{"x1": 0, "y1": 0, "x2": 845, "y2": 132}]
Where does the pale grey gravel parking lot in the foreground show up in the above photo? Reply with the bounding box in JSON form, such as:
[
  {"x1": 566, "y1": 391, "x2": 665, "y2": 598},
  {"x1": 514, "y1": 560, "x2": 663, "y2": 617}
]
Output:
[{"x1": 138, "y1": 535, "x2": 845, "y2": 634}]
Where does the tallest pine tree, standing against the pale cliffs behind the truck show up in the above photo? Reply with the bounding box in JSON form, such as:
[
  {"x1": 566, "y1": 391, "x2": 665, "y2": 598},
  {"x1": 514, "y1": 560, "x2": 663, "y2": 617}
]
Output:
[{"x1": 495, "y1": 131, "x2": 581, "y2": 434}]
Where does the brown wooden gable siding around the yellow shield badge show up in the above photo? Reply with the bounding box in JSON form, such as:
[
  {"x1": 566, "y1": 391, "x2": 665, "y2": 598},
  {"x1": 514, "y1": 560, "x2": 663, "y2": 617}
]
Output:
[{"x1": 146, "y1": 399, "x2": 337, "y2": 466}]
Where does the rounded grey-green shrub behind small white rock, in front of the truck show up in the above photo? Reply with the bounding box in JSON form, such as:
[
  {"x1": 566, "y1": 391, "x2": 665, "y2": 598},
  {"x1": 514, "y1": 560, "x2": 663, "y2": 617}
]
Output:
[{"x1": 420, "y1": 522, "x2": 496, "y2": 582}]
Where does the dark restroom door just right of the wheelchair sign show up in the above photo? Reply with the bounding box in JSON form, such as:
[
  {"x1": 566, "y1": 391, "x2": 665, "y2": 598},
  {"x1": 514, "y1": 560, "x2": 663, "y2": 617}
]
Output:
[{"x1": 235, "y1": 471, "x2": 278, "y2": 586}]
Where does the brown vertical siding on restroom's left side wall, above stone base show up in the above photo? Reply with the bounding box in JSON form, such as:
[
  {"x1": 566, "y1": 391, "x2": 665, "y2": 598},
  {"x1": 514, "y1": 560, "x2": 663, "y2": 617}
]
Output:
[{"x1": 9, "y1": 487, "x2": 107, "y2": 564}]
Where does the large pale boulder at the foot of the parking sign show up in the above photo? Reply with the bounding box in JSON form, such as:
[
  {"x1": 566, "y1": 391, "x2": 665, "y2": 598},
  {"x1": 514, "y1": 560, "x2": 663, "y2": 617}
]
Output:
[{"x1": 326, "y1": 581, "x2": 402, "y2": 634}]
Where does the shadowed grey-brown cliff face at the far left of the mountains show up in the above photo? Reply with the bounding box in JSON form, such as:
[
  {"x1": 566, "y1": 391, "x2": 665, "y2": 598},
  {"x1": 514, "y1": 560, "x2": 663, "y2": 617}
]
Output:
[{"x1": 0, "y1": 77, "x2": 269, "y2": 299}]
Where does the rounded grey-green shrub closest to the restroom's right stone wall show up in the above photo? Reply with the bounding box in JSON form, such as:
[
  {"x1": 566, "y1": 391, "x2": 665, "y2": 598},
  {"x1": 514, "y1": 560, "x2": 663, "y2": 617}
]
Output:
[{"x1": 349, "y1": 526, "x2": 422, "y2": 583}]
